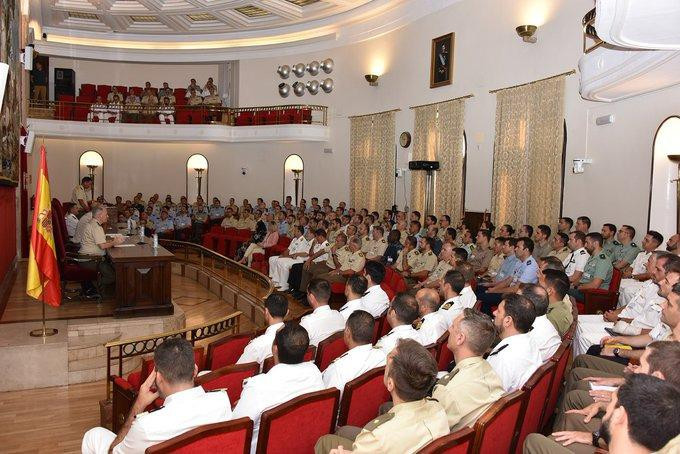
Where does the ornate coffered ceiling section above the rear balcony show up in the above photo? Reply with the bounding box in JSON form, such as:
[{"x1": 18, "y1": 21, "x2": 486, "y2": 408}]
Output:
[{"x1": 41, "y1": 0, "x2": 379, "y2": 35}]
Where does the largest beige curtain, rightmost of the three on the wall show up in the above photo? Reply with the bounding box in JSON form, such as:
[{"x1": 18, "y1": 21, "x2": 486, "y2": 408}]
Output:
[{"x1": 491, "y1": 76, "x2": 565, "y2": 228}]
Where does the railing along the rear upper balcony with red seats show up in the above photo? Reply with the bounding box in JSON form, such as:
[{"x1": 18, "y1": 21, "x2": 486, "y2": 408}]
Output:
[{"x1": 29, "y1": 100, "x2": 328, "y2": 126}]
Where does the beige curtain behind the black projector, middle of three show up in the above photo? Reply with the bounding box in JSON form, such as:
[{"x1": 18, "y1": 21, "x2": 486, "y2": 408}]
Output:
[{"x1": 411, "y1": 99, "x2": 465, "y2": 219}]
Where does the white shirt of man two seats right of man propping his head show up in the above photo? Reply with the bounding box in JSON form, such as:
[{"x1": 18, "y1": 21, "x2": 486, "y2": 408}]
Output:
[{"x1": 322, "y1": 344, "x2": 385, "y2": 398}]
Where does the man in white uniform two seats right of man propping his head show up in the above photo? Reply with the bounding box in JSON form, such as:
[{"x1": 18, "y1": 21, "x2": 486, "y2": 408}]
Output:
[{"x1": 322, "y1": 310, "x2": 385, "y2": 399}]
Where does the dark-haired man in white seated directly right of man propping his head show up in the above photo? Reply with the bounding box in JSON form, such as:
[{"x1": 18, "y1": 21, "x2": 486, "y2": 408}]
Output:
[{"x1": 233, "y1": 323, "x2": 326, "y2": 453}]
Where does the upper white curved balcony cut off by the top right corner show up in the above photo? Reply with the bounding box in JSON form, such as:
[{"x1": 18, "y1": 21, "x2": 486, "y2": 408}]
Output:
[{"x1": 595, "y1": 0, "x2": 680, "y2": 50}]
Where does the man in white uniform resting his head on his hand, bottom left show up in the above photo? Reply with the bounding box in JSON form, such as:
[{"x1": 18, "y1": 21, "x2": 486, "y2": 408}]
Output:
[{"x1": 81, "y1": 338, "x2": 231, "y2": 454}]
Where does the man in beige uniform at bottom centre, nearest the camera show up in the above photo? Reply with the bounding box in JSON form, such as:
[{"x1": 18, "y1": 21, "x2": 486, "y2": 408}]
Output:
[{"x1": 315, "y1": 339, "x2": 449, "y2": 454}]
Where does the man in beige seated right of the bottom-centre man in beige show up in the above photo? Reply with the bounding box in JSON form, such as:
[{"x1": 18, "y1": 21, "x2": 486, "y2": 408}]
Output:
[{"x1": 432, "y1": 308, "x2": 505, "y2": 432}]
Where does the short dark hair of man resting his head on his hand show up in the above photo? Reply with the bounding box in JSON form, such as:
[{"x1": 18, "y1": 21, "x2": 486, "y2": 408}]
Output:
[{"x1": 153, "y1": 337, "x2": 196, "y2": 385}]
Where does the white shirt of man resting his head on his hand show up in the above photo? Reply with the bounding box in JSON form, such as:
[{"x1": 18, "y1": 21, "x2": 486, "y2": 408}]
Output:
[{"x1": 113, "y1": 386, "x2": 231, "y2": 454}]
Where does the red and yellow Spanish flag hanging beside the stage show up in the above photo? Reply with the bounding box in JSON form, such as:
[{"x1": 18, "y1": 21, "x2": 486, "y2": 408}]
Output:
[{"x1": 26, "y1": 145, "x2": 61, "y2": 307}]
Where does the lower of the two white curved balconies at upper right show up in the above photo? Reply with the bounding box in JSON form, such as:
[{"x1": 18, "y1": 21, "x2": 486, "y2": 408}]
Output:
[{"x1": 578, "y1": 45, "x2": 680, "y2": 102}]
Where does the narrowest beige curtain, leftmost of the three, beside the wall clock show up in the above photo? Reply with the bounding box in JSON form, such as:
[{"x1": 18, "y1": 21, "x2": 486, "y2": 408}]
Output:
[{"x1": 349, "y1": 112, "x2": 395, "y2": 211}]
